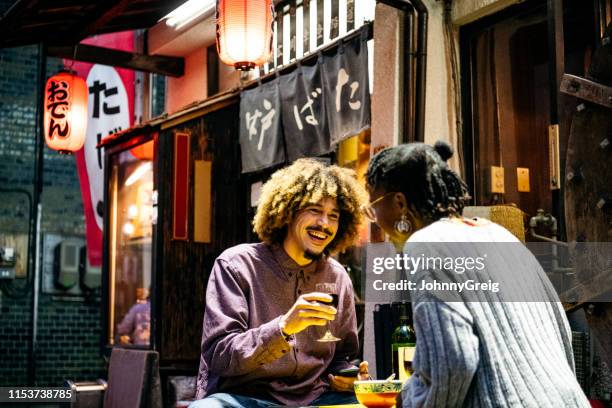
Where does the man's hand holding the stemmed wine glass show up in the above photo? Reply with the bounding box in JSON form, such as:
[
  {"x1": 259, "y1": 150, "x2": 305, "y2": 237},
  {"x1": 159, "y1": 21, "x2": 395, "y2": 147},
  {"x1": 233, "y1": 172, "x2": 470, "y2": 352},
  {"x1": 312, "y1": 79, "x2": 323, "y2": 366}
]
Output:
[{"x1": 280, "y1": 292, "x2": 337, "y2": 335}]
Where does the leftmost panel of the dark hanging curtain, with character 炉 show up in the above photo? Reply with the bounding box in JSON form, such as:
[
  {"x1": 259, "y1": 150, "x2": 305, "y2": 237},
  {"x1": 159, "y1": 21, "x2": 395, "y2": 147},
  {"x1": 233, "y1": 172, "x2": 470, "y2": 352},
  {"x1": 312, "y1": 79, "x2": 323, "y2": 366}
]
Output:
[{"x1": 240, "y1": 80, "x2": 285, "y2": 173}]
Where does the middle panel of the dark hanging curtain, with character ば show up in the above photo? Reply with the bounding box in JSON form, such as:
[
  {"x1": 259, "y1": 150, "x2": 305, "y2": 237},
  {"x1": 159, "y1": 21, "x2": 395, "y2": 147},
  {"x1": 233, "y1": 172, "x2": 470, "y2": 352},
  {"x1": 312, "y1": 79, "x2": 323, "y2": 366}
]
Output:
[{"x1": 279, "y1": 59, "x2": 331, "y2": 162}]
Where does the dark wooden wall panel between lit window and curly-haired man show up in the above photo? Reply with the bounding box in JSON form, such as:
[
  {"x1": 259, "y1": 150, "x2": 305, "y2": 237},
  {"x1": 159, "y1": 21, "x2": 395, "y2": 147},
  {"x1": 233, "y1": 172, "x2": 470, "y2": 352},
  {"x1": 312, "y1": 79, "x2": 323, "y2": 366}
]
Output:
[{"x1": 156, "y1": 104, "x2": 248, "y2": 371}]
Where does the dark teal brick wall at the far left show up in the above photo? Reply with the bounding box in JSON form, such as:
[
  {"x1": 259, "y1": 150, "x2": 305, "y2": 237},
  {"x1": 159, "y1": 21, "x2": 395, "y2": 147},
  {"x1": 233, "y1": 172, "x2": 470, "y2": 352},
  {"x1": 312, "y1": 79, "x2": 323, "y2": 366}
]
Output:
[{"x1": 0, "y1": 44, "x2": 105, "y2": 386}]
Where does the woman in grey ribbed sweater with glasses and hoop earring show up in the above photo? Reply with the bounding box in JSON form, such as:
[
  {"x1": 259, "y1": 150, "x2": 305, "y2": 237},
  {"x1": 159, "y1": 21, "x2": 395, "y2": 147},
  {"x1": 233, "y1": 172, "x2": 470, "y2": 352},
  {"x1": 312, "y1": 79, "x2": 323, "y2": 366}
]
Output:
[{"x1": 365, "y1": 142, "x2": 589, "y2": 408}]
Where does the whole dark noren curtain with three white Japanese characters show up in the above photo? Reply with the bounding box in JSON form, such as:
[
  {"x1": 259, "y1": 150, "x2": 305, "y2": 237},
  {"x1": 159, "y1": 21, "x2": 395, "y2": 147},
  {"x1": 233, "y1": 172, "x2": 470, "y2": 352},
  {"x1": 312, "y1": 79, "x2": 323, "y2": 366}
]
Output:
[{"x1": 240, "y1": 26, "x2": 370, "y2": 173}]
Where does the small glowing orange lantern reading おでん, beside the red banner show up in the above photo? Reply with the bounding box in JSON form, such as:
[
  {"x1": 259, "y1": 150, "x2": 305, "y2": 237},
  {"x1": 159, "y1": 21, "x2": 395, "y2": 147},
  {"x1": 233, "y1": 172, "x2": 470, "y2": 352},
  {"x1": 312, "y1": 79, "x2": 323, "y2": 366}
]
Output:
[{"x1": 44, "y1": 71, "x2": 87, "y2": 153}]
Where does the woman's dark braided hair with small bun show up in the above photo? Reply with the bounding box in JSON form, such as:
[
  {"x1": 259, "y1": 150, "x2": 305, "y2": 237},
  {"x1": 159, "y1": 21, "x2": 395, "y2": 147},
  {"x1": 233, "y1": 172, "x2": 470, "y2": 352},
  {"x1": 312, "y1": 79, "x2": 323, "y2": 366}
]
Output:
[{"x1": 366, "y1": 141, "x2": 470, "y2": 222}]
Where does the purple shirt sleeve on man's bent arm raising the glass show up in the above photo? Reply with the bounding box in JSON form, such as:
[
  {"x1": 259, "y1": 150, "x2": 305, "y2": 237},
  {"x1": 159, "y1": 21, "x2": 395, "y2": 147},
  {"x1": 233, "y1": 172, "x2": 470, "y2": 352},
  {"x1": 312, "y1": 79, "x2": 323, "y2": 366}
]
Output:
[{"x1": 202, "y1": 259, "x2": 291, "y2": 377}]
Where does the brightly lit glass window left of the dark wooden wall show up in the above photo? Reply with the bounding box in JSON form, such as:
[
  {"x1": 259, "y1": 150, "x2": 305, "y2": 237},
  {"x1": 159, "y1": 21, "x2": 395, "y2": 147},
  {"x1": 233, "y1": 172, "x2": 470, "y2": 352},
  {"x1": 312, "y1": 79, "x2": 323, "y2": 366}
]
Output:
[{"x1": 108, "y1": 141, "x2": 154, "y2": 346}]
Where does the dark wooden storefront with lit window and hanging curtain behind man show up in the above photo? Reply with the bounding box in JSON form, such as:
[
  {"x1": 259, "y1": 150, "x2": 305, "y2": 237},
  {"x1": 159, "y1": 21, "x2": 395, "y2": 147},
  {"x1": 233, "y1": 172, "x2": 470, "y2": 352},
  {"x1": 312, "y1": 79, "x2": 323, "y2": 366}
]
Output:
[{"x1": 100, "y1": 3, "x2": 372, "y2": 398}]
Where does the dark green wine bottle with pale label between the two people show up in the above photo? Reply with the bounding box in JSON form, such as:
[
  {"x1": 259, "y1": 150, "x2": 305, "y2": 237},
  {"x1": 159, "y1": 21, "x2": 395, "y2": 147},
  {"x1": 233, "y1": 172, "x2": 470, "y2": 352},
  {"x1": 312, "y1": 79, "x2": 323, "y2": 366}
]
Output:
[{"x1": 391, "y1": 303, "x2": 416, "y2": 381}]
